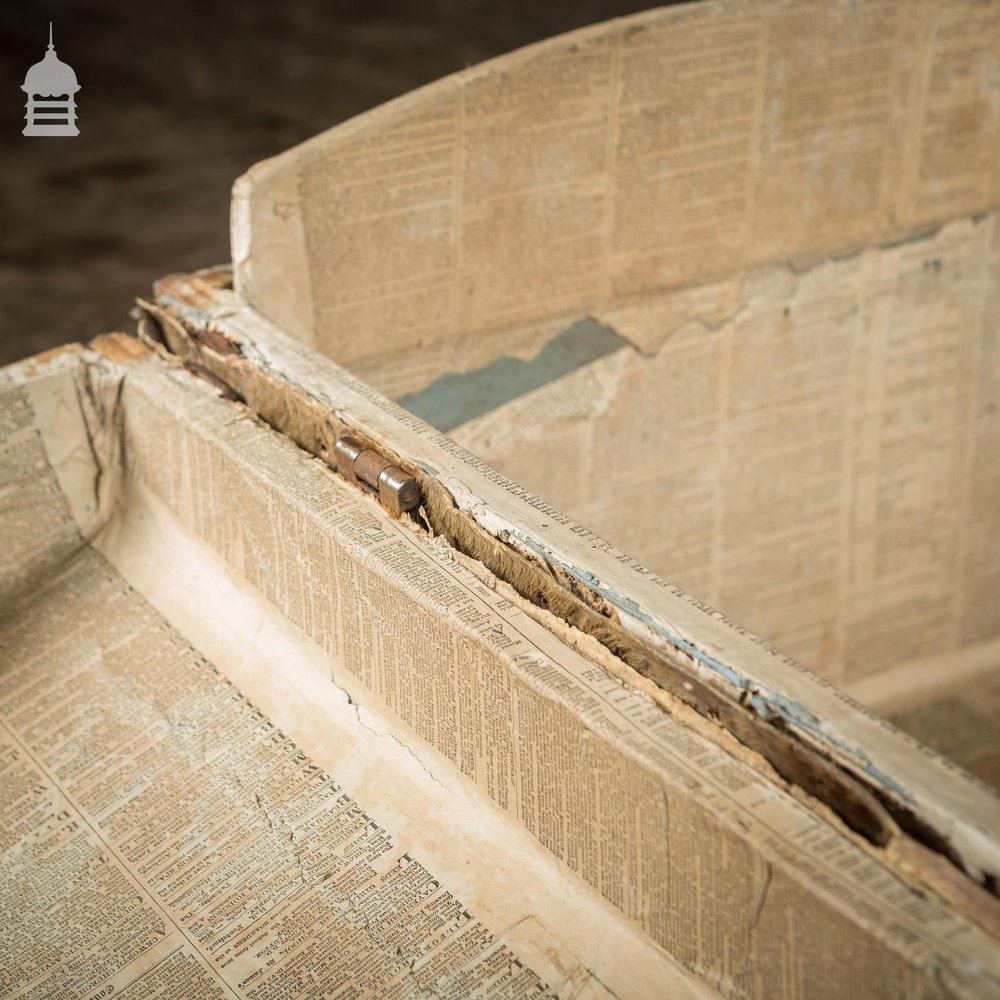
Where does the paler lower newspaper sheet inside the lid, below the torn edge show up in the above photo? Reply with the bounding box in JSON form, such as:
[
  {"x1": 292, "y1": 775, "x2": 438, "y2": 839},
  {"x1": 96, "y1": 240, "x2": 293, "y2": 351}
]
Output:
[{"x1": 450, "y1": 213, "x2": 1000, "y2": 683}]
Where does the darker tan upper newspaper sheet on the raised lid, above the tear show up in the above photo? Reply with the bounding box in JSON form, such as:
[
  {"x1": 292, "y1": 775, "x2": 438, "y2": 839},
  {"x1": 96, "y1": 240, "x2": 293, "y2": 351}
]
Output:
[{"x1": 232, "y1": 0, "x2": 1000, "y2": 382}]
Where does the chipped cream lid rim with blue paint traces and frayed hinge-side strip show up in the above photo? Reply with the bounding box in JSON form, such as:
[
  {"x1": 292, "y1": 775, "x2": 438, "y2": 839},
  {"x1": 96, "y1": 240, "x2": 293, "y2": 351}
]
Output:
[{"x1": 146, "y1": 275, "x2": 1000, "y2": 926}]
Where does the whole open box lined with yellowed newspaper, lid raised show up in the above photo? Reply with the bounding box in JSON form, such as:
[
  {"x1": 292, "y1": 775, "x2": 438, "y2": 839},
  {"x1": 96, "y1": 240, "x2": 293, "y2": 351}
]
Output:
[{"x1": 0, "y1": 0, "x2": 1000, "y2": 1000}]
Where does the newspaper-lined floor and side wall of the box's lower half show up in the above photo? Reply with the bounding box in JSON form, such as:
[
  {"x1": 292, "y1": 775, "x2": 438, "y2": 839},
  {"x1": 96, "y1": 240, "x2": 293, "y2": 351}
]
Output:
[{"x1": 2, "y1": 340, "x2": 1000, "y2": 997}]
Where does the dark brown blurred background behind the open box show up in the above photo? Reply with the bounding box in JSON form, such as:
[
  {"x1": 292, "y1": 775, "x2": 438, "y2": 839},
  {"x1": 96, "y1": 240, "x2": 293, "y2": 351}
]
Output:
[{"x1": 0, "y1": 0, "x2": 672, "y2": 364}]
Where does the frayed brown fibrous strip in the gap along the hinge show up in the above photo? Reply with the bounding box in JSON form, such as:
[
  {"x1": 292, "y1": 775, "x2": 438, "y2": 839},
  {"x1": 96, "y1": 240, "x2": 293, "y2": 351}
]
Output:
[{"x1": 137, "y1": 299, "x2": 998, "y2": 923}]
